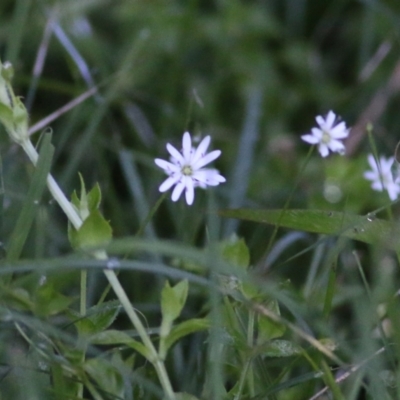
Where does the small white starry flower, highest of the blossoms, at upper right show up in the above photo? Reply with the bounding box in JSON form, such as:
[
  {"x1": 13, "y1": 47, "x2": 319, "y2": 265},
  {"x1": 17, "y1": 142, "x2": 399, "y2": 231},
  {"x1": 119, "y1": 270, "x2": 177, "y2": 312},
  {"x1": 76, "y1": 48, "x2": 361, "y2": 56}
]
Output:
[{"x1": 301, "y1": 111, "x2": 349, "y2": 157}]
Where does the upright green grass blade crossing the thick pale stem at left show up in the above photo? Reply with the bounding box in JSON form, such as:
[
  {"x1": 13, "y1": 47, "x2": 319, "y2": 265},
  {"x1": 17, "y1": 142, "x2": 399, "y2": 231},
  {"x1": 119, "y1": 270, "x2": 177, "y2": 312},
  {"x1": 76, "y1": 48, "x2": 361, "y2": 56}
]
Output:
[{"x1": 7, "y1": 134, "x2": 54, "y2": 261}]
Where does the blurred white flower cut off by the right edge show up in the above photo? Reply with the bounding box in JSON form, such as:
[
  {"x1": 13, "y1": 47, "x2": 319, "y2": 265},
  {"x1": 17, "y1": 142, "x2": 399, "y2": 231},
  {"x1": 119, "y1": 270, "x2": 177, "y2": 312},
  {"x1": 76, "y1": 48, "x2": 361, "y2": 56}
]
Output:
[{"x1": 364, "y1": 154, "x2": 400, "y2": 201}]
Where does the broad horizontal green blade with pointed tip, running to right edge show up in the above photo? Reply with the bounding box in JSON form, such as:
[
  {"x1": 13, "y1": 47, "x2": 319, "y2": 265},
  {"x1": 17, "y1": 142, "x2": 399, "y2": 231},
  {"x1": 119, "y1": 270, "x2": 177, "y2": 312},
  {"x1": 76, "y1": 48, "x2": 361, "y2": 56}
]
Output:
[{"x1": 220, "y1": 209, "x2": 400, "y2": 250}]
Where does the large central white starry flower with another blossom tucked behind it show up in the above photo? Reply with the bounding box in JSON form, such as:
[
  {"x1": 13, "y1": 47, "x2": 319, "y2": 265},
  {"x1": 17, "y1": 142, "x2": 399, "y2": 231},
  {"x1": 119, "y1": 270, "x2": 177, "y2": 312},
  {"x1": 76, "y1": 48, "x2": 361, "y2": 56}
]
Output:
[{"x1": 154, "y1": 132, "x2": 226, "y2": 205}]
